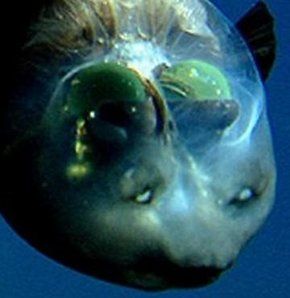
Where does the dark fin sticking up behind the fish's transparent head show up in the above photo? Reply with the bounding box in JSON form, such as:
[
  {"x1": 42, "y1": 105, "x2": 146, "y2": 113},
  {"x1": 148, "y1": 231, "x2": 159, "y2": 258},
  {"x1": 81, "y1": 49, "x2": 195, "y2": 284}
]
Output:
[{"x1": 236, "y1": 1, "x2": 276, "y2": 82}]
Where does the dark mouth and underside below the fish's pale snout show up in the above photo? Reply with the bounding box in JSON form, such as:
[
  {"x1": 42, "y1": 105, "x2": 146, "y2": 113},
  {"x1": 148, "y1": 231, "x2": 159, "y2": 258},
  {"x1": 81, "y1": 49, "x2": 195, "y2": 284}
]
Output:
[{"x1": 67, "y1": 254, "x2": 232, "y2": 292}]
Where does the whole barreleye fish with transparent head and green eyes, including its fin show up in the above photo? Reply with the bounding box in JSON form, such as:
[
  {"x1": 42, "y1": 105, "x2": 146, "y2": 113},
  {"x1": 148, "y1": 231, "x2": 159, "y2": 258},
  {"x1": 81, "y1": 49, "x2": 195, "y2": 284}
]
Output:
[{"x1": 0, "y1": 0, "x2": 276, "y2": 290}]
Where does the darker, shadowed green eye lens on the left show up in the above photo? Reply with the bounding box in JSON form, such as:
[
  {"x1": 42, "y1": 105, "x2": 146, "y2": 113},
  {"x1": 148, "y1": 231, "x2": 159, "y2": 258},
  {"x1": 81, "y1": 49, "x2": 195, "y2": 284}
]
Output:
[{"x1": 68, "y1": 63, "x2": 146, "y2": 114}]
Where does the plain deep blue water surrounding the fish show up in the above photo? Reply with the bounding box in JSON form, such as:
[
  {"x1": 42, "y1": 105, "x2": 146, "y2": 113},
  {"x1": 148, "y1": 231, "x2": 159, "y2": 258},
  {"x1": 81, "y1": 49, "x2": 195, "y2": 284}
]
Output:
[{"x1": 0, "y1": 0, "x2": 290, "y2": 298}]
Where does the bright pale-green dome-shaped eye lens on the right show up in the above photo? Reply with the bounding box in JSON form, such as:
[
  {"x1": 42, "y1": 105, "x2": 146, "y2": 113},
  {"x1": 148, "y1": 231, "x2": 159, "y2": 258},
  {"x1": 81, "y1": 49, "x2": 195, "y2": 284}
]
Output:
[{"x1": 160, "y1": 60, "x2": 231, "y2": 100}]
